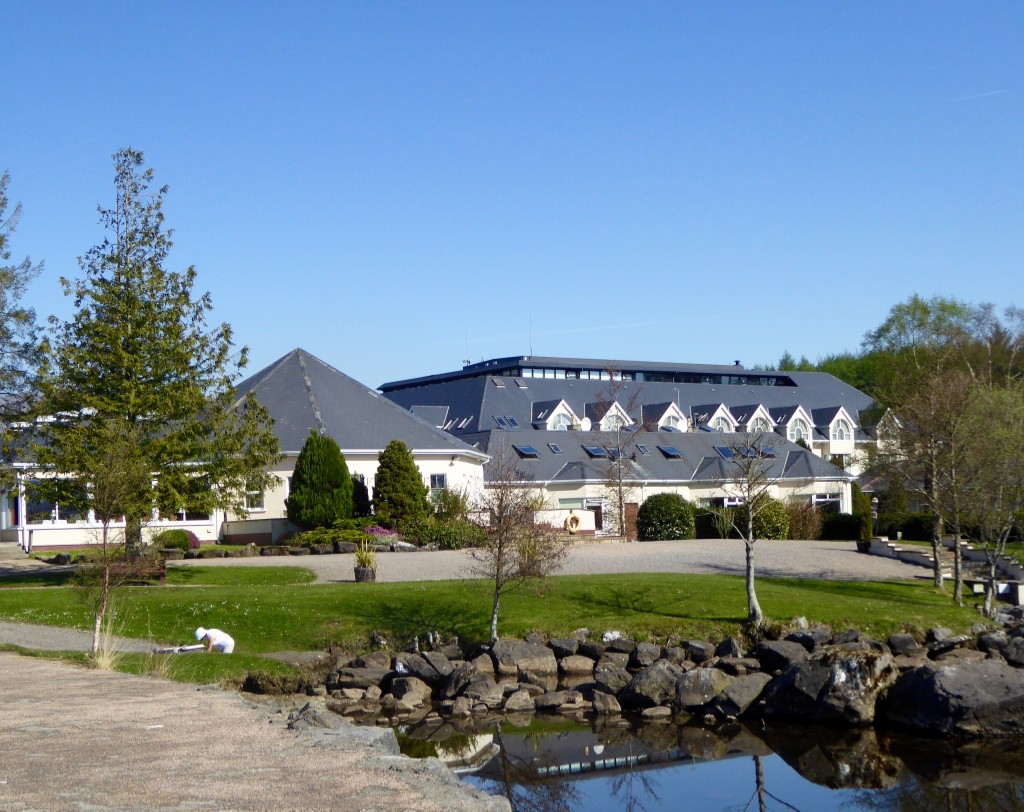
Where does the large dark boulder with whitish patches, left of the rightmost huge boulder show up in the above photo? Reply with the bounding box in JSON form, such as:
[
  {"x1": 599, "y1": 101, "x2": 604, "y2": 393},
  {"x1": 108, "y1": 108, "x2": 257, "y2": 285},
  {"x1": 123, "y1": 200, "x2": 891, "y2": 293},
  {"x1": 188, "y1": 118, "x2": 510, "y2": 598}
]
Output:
[{"x1": 761, "y1": 647, "x2": 898, "y2": 725}]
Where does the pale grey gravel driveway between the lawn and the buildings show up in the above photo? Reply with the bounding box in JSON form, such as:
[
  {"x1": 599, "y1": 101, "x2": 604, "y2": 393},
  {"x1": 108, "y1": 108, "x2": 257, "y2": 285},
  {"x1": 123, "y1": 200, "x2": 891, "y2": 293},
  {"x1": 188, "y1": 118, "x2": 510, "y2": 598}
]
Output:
[{"x1": 170, "y1": 539, "x2": 931, "y2": 584}]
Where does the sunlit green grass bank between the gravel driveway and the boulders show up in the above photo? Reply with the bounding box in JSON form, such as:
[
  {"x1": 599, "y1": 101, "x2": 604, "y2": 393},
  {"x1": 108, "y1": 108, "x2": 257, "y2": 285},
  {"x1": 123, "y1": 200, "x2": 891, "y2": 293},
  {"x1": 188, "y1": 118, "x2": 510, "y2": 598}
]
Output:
[{"x1": 0, "y1": 567, "x2": 978, "y2": 655}]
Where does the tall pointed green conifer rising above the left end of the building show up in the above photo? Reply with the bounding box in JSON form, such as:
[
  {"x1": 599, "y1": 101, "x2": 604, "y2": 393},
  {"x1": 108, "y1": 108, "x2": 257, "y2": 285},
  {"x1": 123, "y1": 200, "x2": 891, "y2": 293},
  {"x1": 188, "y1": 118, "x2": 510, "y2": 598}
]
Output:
[{"x1": 31, "y1": 149, "x2": 278, "y2": 547}]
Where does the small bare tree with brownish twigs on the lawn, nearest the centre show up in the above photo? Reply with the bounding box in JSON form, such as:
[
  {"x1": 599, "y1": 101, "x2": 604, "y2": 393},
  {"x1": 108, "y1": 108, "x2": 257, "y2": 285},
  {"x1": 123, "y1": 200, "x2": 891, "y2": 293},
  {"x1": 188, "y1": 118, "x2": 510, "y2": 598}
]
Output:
[{"x1": 470, "y1": 445, "x2": 568, "y2": 642}]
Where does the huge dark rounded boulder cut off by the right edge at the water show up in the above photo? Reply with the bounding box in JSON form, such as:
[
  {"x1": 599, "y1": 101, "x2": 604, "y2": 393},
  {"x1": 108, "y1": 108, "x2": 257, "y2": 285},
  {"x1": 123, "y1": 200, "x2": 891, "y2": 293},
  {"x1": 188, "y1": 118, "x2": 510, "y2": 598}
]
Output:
[{"x1": 879, "y1": 660, "x2": 1024, "y2": 736}]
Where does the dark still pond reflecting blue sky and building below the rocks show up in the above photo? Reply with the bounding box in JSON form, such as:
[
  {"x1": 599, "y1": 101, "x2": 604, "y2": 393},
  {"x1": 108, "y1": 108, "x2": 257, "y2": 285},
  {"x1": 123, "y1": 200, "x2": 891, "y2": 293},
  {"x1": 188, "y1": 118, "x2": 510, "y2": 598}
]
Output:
[{"x1": 396, "y1": 717, "x2": 1024, "y2": 812}]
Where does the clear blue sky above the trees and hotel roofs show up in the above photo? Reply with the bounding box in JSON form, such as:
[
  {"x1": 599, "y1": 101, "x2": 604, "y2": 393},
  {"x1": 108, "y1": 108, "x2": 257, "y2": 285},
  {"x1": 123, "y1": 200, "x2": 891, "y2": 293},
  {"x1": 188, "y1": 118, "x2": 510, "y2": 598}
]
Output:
[{"x1": 0, "y1": 0, "x2": 1024, "y2": 386}]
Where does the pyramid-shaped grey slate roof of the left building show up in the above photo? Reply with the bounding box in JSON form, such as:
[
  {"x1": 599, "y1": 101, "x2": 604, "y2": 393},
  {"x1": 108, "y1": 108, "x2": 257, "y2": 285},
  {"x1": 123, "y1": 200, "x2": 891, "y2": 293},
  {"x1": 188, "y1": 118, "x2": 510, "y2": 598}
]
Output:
[{"x1": 236, "y1": 348, "x2": 478, "y2": 456}]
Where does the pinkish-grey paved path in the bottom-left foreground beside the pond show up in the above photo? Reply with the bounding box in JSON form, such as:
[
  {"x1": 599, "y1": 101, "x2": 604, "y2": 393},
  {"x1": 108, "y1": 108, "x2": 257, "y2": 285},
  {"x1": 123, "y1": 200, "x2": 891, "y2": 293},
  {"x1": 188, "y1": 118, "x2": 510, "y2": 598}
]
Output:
[{"x1": 0, "y1": 652, "x2": 508, "y2": 812}]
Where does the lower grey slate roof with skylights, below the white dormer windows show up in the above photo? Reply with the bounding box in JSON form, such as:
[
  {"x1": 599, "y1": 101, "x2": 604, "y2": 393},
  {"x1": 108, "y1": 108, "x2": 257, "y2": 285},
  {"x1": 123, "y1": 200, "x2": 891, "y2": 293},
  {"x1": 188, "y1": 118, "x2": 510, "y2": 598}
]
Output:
[{"x1": 467, "y1": 430, "x2": 852, "y2": 484}]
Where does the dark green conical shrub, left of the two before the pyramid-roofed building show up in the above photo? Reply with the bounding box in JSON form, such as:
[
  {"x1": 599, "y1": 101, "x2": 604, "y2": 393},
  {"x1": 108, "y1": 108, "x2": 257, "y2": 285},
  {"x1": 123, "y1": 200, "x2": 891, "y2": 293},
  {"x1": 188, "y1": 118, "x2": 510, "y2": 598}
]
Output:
[{"x1": 285, "y1": 429, "x2": 352, "y2": 528}]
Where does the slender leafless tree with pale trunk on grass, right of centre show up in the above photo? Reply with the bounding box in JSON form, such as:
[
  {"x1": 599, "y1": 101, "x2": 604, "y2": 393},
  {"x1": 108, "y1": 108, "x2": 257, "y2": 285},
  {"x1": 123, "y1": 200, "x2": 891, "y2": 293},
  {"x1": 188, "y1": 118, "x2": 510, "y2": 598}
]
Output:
[{"x1": 719, "y1": 431, "x2": 777, "y2": 628}]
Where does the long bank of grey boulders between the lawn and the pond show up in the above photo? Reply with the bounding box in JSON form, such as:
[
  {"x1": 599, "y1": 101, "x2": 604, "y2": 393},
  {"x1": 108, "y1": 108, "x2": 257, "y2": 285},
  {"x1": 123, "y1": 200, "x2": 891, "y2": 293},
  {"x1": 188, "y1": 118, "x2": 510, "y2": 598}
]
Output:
[{"x1": 256, "y1": 607, "x2": 1024, "y2": 736}]
